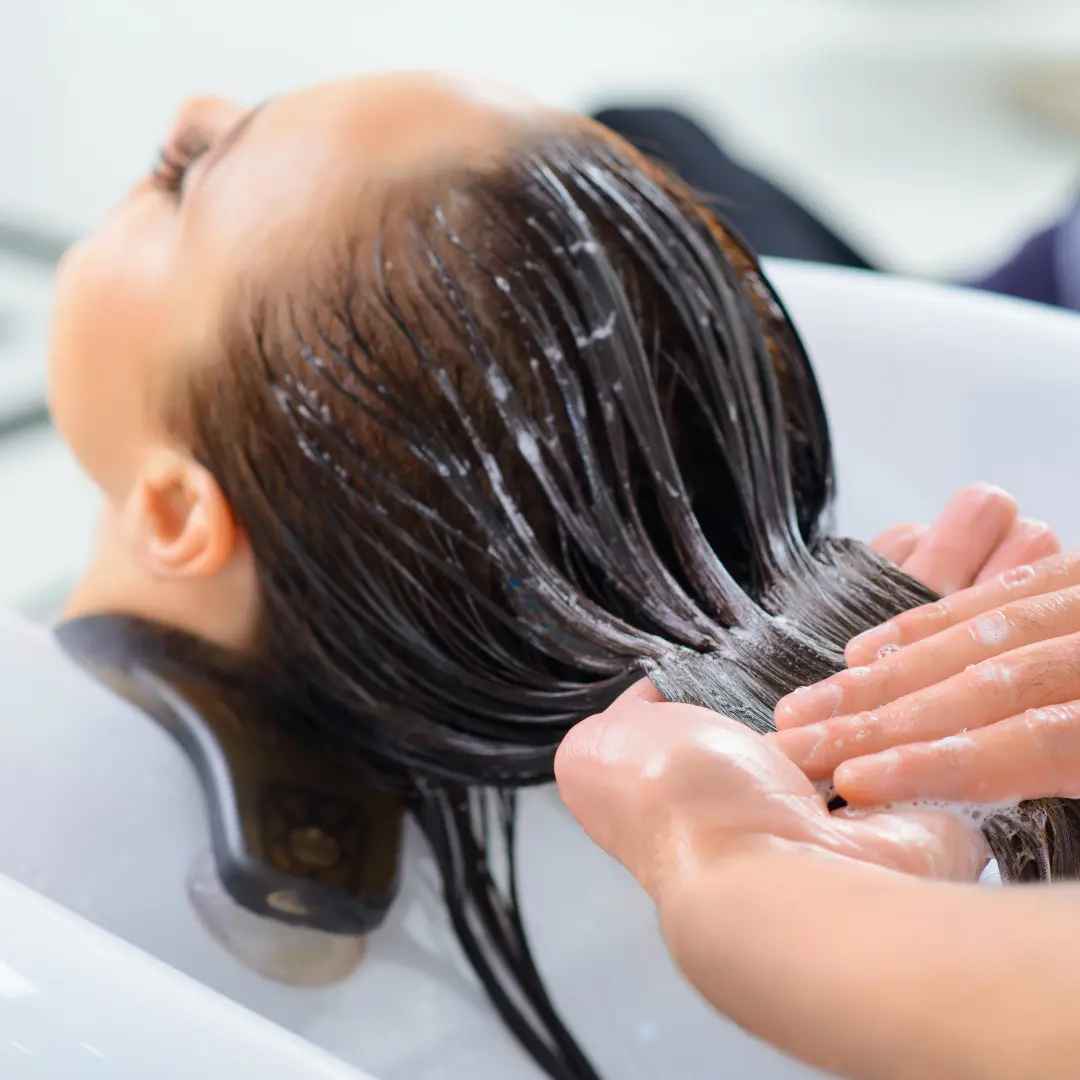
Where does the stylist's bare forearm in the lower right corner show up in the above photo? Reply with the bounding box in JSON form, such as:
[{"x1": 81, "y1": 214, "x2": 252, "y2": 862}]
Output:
[{"x1": 660, "y1": 843, "x2": 1080, "y2": 1080}]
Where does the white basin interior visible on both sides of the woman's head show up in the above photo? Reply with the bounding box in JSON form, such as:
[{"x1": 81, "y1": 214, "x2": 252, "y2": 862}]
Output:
[{"x1": 0, "y1": 265, "x2": 1080, "y2": 1080}]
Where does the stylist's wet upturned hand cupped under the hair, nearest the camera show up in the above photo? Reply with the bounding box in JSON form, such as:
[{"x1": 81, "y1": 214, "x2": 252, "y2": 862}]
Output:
[{"x1": 555, "y1": 680, "x2": 987, "y2": 908}]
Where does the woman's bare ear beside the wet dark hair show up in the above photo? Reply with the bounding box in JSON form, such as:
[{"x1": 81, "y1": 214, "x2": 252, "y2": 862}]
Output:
[{"x1": 120, "y1": 450, "x2": 241, "y2": 579}]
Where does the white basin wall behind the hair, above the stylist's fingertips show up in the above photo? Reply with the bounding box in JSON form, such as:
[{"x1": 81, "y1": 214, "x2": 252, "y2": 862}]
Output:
[{"x1": 769, "y1": 261, "x2": 1080, "y2": 546}]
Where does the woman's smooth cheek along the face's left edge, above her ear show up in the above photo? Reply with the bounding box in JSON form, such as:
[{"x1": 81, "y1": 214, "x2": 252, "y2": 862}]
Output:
[{"x1": 49, "y1": 220, "x2": 169, "y2": 495}]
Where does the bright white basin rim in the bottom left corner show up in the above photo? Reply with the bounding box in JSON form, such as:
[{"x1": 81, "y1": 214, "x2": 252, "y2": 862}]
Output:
[{"x1": 0, "y1": 879, "x2": 365, "y2": 1080}]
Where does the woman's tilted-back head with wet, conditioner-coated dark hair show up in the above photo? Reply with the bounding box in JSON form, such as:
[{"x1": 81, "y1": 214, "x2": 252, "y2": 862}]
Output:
[{"x1": 53, "y1": 69, "x2": 851, "y2": 781}]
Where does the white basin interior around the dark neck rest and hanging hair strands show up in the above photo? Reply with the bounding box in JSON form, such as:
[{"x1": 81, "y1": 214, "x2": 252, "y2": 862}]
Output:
[{"x1": 0, "y1": 622, "x2": 791, "y2": 1080}]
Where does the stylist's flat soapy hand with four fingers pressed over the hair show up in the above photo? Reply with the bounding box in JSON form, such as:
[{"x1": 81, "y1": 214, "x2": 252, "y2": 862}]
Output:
[{"x1": 768, "y1": 552, "x2": 1080, "y2": 806}]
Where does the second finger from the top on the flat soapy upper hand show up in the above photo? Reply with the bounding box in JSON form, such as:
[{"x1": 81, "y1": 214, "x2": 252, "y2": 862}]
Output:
[{"x1": 775, "y1": 585, "x2": 1080, "y2": 730}]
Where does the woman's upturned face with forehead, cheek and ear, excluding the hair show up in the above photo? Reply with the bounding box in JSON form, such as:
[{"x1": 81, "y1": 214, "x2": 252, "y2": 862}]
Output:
[{"x1": 51, "y1": 76, "x2": 552, "y2": 642}]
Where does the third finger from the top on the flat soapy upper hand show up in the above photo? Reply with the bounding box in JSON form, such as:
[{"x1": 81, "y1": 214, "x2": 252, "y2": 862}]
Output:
[{"x1": 767, "y1": 634, "x2": 1080, "y2": 780}]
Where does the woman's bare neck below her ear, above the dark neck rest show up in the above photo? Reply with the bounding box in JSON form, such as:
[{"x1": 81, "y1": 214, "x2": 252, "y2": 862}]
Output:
[{"x1": 62, "y1": 511, "x2": 257, "y2": 651}]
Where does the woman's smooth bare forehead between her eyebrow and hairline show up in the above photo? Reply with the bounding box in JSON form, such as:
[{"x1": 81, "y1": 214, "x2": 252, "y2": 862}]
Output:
[{"x1": 181, "y1": 75, "x2": 545, "y2": 304}]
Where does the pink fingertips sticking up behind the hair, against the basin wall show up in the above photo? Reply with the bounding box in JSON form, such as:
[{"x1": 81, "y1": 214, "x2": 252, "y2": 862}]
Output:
[{"x1": 869, "y1": 484, "x2": 1061, "y2": 596}]
